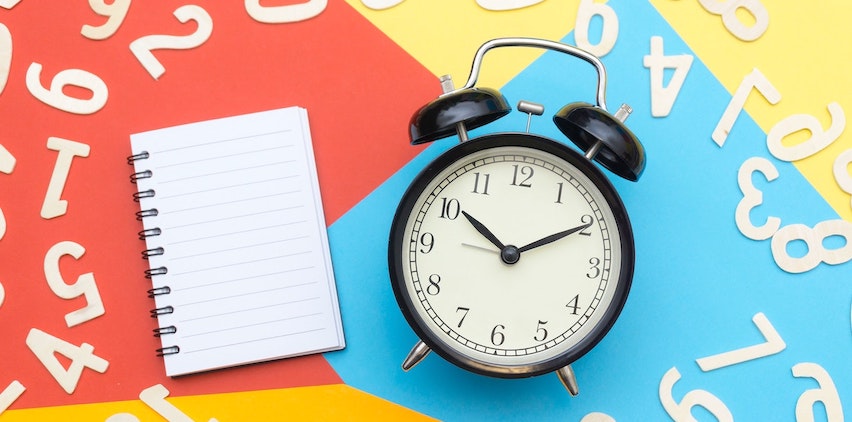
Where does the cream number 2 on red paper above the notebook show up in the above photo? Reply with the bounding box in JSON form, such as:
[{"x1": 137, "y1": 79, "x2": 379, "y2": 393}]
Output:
[{"x1": 130, "y1": 4, "x2": 213, "y2": 79}]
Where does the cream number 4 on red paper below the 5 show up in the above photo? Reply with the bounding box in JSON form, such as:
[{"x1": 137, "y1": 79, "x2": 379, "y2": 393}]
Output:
[{"x1": 27, "y1": 328, "x2": 109, "y2": 394}]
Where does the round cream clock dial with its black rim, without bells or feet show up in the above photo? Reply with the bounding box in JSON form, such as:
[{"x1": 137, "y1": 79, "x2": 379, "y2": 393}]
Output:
[{"x1": 389, "y1": 133, "x2": 634, "y2": 377}]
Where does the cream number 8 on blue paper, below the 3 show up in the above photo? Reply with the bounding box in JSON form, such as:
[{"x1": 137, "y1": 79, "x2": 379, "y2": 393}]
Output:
[{"x1": 772, "y1": 220, "x2": 852, "y2": 273}]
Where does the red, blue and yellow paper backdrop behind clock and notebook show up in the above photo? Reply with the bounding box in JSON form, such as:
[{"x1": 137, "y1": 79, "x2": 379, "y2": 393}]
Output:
[{"x1": 0, "y1": 0, "x2": 852, "y2": 422}]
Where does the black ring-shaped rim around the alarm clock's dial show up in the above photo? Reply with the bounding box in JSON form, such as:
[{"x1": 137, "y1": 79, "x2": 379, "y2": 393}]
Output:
[{"x1": 388, "y1": 132, "x2": 635, "y2": 378}]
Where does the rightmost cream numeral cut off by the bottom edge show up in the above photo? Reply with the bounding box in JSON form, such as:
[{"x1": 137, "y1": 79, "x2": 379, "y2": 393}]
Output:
[{"x1": 793, "y1": 362, "x2": 843, "y2": 422}]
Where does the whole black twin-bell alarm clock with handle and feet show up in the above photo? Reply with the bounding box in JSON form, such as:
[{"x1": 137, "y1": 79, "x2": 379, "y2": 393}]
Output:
[{"x1": 388, "y1": 38, "x2": 645, "y2": 395}]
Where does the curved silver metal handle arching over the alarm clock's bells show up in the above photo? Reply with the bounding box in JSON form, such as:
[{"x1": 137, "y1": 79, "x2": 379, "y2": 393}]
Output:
[{"x1": 456, "y1": 37, "x2": 606, "y2": 110}]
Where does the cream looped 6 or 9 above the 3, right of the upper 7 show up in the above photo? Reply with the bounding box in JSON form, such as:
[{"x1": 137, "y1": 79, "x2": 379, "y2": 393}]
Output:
[{"x1": 766, "y1": 102, "x2": 846, "y2": 161}]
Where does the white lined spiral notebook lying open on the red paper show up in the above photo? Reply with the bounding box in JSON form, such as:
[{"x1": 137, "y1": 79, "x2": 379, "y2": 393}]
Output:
[{"x1": 128, "y1": 107, "x2": 345, "y2": 376}]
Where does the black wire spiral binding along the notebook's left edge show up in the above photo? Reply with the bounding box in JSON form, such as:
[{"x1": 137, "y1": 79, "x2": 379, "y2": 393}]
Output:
[{"x1": 127, "y1": 151, "x2": 180, "y2": 356}]
